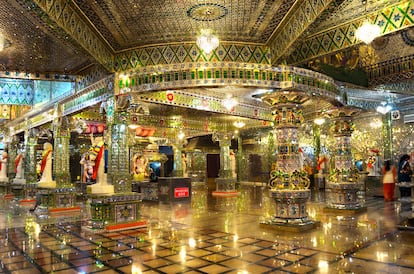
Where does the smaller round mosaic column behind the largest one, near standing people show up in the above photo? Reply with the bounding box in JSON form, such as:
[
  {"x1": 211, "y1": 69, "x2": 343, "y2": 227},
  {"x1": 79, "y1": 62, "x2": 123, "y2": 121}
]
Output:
[{"x1": 326, "y1": 107, "x2": 363, "y2": 210}]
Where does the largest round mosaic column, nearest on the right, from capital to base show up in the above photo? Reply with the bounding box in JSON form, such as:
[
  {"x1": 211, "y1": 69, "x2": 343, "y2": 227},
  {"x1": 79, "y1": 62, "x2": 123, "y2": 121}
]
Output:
[{"x1": 262, "y1": 91, "x2": 315, "y2": 230}]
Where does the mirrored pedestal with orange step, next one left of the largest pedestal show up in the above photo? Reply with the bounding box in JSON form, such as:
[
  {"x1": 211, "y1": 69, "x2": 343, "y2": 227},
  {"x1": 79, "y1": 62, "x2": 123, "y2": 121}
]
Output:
[{"x1": 36, "y1": 187, "x2": 80, "y2": 214}]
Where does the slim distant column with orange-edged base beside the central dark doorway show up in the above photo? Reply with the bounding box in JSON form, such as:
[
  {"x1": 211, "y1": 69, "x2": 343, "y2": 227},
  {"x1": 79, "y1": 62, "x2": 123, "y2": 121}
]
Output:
[{"x1": 212, "y1": 132, "x2": 238, "y2": 196}]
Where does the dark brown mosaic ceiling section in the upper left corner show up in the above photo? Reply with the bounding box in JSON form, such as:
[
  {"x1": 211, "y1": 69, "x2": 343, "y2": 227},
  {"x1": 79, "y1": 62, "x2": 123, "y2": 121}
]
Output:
[{"x1": 0, "y1": 0, "x2": 93, "y2": 73}]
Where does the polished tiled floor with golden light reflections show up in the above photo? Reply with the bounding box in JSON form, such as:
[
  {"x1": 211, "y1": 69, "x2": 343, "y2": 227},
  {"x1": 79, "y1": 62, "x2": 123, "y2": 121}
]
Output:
[{"x1": 0, "y1": 183, "x2": 414, "y2": 274}]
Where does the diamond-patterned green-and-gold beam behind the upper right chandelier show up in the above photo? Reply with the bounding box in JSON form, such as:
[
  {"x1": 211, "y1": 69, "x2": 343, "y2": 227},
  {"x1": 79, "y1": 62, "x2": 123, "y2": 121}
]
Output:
[{"x1": 287, "y1": 1, "x2": 414, "y2": 64}]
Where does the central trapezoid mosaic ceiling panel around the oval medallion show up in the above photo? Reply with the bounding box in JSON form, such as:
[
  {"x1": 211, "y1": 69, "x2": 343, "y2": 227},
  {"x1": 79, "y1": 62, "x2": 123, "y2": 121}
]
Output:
[{"x1": 75, "y1": 0, "x2": 294, "y2": 51}]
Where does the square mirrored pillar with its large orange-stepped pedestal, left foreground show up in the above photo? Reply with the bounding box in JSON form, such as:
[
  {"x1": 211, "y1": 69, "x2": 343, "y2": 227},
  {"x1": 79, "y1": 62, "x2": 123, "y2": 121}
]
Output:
[{"x1": 87, "y1": 97, "x2": 146, "y2": 231}]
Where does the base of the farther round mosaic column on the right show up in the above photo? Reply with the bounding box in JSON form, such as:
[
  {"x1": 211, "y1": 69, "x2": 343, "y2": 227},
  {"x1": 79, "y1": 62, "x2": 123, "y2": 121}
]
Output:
[{"x1": 324, "y1": 181, "x2": 366, "y2": 214}]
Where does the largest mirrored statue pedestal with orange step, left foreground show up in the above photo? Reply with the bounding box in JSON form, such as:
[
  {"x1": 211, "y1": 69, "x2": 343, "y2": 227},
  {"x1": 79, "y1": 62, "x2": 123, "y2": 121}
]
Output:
[{"x1": 86, "y1": 192, "x2": 147, "y2": 231}]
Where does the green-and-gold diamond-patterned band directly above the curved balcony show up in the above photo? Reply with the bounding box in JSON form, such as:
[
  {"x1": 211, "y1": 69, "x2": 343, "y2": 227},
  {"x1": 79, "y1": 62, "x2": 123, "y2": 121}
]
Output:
[{"x1": 114, "y1": 42, "x2": 270, "y2": 72}]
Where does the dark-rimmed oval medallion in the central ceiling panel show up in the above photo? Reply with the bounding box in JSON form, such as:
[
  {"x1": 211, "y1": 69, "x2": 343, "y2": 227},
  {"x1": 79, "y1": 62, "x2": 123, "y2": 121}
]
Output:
[{"x1": 187, "y1": 3, "x2": 228, "y2": 21}]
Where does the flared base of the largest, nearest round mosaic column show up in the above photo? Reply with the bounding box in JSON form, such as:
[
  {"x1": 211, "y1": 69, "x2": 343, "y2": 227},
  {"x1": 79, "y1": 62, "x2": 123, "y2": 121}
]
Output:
[{"x1": 260, "y1": 189, "x2": 320, "y2": 232}]
